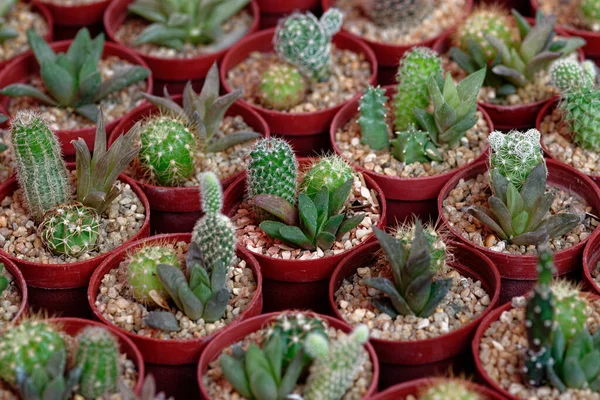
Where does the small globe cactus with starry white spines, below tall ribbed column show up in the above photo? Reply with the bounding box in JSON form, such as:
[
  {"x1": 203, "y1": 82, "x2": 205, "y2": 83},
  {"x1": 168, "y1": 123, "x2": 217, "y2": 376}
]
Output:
[{"x1": 38, "y1": 203, "x2": 100, "y2": 257}]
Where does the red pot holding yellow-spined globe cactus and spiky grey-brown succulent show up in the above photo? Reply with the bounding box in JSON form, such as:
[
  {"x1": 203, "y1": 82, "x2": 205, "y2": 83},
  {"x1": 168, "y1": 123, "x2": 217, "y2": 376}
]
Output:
[{"x1": 109, "y1": 95, "x2": 269, "y2": 233}]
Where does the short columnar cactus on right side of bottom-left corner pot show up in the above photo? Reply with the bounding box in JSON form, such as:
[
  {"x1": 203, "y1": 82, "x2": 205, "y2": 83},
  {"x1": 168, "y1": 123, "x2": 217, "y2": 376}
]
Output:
[{"x1": 76, "y1": 326, "x2": 119, "y2": 399}]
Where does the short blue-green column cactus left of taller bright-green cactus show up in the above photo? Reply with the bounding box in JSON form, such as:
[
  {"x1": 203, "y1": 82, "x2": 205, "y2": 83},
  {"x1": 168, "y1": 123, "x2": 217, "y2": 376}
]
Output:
[{"x1": 358, "y1": 86, "x2": 390, "y2": 150}]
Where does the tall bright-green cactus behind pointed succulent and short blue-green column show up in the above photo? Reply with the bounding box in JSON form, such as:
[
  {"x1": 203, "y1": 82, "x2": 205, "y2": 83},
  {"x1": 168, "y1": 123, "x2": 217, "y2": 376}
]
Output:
[{"x1": 394, "y1": 47, "x2": 442, "y2": 131}]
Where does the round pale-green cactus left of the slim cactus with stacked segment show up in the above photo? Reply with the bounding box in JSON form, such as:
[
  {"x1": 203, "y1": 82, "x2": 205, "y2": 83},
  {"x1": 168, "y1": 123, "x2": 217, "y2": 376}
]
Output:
[{"x1": 127, "y1": 246, "x2": 179, "y2": 304}]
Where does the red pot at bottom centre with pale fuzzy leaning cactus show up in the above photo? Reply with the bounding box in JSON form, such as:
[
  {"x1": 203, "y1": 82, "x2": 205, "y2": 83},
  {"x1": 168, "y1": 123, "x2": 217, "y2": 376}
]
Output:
[{"x1": 197, "y1": 313, "x2": 379, "y2": 400}]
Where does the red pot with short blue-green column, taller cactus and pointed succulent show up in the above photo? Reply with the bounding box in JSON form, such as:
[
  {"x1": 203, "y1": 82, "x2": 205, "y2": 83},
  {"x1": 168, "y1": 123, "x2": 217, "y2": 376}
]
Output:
[{"x1": 329, "y1": 86, "x2": 494, "y2": 224}]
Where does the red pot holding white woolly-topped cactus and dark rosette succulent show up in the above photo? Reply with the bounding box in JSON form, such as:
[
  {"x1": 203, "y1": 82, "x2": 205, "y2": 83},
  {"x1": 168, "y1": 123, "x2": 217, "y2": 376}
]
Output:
[{"x1": 438, "y1": 159, "x2": 600, "y2": 302}]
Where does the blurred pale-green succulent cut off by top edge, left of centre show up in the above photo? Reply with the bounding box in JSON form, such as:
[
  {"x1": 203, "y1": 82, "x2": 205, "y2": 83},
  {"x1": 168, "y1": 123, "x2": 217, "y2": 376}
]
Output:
[{"x1": 128, "y1": 0, "x2": 250, "y2": 52}]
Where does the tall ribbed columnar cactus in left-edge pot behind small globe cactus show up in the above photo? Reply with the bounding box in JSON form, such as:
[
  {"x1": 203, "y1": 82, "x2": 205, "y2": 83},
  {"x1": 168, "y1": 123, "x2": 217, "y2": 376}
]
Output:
[{"x1": 10, "y1": 111, "x2": 71, "y2": 222}]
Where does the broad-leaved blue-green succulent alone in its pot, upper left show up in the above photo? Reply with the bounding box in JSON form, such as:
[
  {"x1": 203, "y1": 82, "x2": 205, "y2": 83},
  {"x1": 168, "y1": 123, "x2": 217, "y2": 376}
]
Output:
[{"x1": 0, "y1": 28, "x2": 150, "y2": 122}]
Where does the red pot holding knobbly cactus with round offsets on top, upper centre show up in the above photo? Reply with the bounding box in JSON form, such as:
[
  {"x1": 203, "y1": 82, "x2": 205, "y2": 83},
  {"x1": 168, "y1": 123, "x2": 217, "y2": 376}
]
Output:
[{"x1": 220, "y1": 29, "x2": 377, "y2": 156}]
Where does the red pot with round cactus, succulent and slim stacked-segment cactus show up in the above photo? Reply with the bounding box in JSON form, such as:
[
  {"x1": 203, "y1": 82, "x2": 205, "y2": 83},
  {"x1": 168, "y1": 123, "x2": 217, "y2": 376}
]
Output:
[{"x1": 88, "y1": 233, "x2": 262, "y2": 365}]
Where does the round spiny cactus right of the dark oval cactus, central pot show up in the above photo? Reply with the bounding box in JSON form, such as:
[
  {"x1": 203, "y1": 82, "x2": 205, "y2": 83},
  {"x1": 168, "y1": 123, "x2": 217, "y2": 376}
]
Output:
[{"x1": 300, "y1": 155, "x2": 354, "y2": 199}]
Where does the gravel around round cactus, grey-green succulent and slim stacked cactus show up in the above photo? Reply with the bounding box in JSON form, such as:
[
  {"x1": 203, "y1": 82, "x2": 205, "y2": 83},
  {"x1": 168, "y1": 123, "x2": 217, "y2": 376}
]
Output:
[{"x1": 95, "y1": 242, "x2": 257, "y2": 340}]
